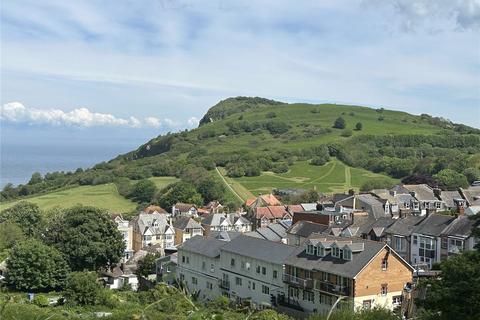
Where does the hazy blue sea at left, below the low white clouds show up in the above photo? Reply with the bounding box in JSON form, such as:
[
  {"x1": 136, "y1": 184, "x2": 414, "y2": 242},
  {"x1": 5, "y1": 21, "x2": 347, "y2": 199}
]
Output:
[{"x1": 0, "y1": 127, "x2": 158, "y2": 189}]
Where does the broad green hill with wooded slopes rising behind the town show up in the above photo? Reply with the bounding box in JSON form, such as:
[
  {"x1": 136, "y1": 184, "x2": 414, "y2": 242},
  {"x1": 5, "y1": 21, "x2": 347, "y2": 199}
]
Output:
[{"x1": 2, "y1": 97, "x2": 480, "y2": 210}]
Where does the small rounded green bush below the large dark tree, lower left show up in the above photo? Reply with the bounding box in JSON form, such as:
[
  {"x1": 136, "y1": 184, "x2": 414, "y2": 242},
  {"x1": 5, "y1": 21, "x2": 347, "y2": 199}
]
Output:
[{"x1": 64, "y1": 272, "x2": 102, "y2": 306}]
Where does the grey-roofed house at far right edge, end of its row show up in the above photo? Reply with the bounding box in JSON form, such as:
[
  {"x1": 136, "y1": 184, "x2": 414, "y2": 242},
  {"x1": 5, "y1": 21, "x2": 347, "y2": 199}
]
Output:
[{"x1": 440, "y1": 215, "x2": 480, "y2": 260}]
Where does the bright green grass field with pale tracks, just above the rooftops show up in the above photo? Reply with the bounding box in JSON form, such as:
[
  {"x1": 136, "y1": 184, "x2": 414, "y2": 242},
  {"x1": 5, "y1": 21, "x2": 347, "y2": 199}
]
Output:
[{"x1": 229, "y1": 160, "x2": 398, "y2": 194}]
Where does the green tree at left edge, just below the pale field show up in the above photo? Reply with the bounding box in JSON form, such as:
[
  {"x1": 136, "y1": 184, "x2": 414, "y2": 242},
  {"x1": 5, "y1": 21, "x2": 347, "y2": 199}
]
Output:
[{"x1": 0, "y1": 201, "x2": 42, "y2": 236}]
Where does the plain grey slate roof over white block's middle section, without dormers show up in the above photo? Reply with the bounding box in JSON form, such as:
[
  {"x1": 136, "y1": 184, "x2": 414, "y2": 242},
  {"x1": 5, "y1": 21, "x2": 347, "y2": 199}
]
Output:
[{"x1": 221, "y1": 235, "x2": 295, "y2": 264}]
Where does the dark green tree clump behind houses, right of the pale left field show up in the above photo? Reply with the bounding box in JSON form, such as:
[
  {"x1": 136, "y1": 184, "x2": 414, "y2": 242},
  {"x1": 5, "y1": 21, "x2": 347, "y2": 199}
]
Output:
[{"x1": 154, "y1": 182, "x2": 203, "y2": 210}]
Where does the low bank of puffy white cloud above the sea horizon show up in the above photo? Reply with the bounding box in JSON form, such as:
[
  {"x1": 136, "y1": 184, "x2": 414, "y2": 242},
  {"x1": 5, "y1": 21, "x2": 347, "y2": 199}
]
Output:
[{"x1": 0, "y1": 102, "x2": 198, "y2": 129}]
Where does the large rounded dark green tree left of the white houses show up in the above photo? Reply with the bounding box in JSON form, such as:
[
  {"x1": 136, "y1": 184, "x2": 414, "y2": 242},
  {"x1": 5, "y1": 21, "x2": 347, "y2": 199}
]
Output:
[{"x1": 45, "y1": 206, "x2": 125, "y2": 271}]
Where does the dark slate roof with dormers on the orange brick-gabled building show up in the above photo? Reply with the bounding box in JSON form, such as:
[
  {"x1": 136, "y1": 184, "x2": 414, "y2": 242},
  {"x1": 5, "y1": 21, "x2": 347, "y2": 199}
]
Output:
[{"x1": 285, "y1": 235, "x2": 386, "y2": 278}]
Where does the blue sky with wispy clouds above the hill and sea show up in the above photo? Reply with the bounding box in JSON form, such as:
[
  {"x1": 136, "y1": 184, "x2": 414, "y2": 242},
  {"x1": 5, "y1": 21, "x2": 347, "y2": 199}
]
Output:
[{"x1": 0, "y1": 0, "x2": 480, "y2": 131}]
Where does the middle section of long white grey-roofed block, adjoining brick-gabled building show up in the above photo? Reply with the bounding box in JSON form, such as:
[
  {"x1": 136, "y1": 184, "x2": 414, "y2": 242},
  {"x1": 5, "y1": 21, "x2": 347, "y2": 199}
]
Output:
[{"x1": 220, "y1": 235, "x2": 295, "y2": 309}]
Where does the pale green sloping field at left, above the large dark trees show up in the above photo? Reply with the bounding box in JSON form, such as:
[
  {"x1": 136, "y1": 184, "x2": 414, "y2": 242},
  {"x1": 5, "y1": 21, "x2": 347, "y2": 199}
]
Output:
[{"x1": 0, "y1": 183, "x2": 137, "y2": 212}]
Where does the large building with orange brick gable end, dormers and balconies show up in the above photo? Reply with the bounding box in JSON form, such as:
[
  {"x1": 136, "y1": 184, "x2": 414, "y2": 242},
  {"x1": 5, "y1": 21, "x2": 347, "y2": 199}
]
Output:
[{"x1": 279, "y1": 234, "x2": 413, "y2": 314}]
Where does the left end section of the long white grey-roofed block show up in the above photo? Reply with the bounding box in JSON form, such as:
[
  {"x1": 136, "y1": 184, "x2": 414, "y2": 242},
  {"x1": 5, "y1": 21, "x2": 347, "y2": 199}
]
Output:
[{"x1": 176, "y1": 236, "x2": 229, "y2": 301}]
